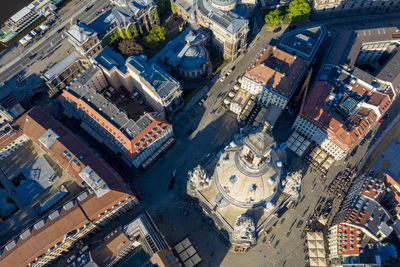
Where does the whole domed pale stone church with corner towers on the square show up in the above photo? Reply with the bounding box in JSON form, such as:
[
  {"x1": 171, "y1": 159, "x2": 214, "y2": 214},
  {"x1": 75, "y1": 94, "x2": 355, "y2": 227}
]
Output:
[{"x1": 187, "y1": 130, "x2": 290, "y2": 252}]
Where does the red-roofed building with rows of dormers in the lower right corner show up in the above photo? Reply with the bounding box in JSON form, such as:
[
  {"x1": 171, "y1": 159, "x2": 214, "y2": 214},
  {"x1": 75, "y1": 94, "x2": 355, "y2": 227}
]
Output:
[{"x1": 328, "y1": 171, "x2": 399, "y2": 265}]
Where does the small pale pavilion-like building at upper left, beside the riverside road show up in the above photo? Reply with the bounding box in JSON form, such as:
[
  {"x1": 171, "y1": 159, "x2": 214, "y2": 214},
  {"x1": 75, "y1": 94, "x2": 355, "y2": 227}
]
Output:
[{"x1": 66, "y1": 21, "x2": 103, "y2": 57}]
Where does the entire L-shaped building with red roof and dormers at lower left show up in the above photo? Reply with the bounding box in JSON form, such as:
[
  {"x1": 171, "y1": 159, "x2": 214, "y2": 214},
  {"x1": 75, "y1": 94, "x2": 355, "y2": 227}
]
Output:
[{"x1": 0, "y1": 108, "x2": 138, "y2": 266}]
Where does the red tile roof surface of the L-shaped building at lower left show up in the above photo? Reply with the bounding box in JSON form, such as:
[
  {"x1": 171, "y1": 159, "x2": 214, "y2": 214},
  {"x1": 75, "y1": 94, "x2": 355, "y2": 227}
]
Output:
[{"x1": 0, "y1": 107, "x2": 135, "y2": 266}]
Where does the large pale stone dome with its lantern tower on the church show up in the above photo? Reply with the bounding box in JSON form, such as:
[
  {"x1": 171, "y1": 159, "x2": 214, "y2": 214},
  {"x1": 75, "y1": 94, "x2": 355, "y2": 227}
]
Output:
[{"x1": 214, "y1": 131, "x2": 282, "y2": 208}]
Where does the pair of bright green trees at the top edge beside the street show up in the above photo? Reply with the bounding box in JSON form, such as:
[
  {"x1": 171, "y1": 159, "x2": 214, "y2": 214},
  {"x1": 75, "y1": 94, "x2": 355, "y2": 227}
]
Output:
[{"x1": 265, "y1": 0, "x2": 311, "y2": 26}]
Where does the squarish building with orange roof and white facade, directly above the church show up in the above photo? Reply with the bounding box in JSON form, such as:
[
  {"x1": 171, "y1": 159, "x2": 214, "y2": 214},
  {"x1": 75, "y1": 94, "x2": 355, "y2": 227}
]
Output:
[{"x1": 242, "y1": 45, "x2": 307, "y2": 109}]
